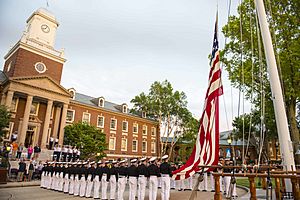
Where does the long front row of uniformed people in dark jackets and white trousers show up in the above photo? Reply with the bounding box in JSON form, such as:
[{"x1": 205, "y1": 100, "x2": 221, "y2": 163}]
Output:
[{"x1": 41, "y1": 155, "x2": 236, "y2": 200}]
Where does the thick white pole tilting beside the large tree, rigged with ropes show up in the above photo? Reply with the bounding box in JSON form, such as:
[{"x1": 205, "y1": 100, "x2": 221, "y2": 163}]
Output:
[{"x1": 255, "y1": 0, "x2": 295, "y2": 192}]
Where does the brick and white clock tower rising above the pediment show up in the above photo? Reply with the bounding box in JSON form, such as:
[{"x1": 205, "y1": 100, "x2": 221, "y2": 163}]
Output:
[{"x1": 3, "y1": 8, "x2": 66, "y2": 83}]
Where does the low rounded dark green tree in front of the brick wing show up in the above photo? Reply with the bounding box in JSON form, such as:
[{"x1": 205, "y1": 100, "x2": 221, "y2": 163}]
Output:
[{"x1": 64, "y1": 122, "x2": 107, "y2": 159}]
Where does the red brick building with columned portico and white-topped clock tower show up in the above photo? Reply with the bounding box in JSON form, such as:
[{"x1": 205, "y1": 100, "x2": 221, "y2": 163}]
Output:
[{"x1": 0, "y1": 9, "x2": 160, "y2": 157}]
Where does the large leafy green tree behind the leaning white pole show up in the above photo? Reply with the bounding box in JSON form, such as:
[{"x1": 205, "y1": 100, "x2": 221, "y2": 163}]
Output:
[{"x1": 222, "y1": 0, "x2": 300, "y2": 162}]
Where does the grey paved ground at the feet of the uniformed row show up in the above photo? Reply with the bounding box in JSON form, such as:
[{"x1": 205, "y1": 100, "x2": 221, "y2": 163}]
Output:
[{"x1": 0, "y1": 186, "x2": 246, "y2": 200}]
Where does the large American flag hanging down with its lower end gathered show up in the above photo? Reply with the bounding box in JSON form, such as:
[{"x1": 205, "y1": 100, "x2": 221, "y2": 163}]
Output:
[{"x1": 172, "y1": 14, "x2": 223, "y2": 180}]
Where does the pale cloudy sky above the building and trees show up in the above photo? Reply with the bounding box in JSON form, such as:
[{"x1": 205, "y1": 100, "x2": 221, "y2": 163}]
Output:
[{"x1": 0, "y1": 0, "x2": 250, "y2": 131}]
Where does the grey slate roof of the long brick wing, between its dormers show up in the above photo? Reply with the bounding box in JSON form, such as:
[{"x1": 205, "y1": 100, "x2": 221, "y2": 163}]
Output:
[{"x1": 73, "y1": 92, "x2": 155, "y2": 121}]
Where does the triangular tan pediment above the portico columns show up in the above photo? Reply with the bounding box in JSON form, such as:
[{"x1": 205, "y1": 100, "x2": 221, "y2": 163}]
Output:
[{"x1": 11, "y1": 76, "x2": 71, "y2": 97}]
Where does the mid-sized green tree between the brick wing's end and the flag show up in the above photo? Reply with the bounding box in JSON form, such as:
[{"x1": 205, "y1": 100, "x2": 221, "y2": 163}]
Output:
[{"x1": 131, "y1": 80, "x2": 191, "y2": 154}]
